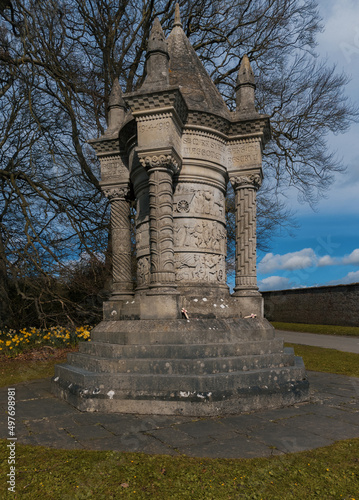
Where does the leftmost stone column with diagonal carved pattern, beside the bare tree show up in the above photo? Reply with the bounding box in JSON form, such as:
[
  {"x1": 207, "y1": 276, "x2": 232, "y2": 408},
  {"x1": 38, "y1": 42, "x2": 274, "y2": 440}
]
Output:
[{"x1": 104, "y1": 185, "x2": 133, "y2": 300}]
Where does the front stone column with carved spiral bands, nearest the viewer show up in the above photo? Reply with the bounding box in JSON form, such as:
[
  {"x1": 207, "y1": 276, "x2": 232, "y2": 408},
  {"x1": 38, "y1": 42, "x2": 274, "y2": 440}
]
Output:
[{"x1": 140, "y1": 154, "x2": 178, "y2": 294}]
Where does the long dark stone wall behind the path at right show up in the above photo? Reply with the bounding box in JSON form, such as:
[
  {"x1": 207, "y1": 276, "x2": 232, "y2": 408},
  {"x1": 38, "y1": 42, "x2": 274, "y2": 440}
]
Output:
[{"x1": 262, "y1": 283, "x2": 359, "y2": 326}]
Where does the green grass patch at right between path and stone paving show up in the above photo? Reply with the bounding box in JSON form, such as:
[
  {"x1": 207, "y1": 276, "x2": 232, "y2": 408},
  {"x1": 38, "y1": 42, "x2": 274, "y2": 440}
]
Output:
[{"x1": 285, "y1": 343, "x2": 359, "y2": 377}]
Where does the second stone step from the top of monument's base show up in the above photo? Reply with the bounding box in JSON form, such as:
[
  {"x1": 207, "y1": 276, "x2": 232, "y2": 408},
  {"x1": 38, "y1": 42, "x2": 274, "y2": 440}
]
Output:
[{"x1": 79, "y1": 339, "x2": 283, "y2": 359}]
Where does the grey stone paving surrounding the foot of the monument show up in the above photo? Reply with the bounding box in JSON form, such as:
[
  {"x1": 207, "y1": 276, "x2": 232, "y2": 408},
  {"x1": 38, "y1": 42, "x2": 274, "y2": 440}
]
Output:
[{"x1": 0, "y1": 372, "x2": 359, "y2": 458}]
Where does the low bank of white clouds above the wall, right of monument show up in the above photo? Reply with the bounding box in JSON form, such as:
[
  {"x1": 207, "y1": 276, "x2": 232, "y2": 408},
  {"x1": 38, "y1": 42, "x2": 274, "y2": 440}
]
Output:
[{"x1": 258, "y1": 248, "x2": 359, "y2": 274}]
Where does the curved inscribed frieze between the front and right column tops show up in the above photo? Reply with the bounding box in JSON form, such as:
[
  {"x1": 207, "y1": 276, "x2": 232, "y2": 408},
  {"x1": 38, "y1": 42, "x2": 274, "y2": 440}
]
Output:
[{"x1": 182, "y1": 134, "x2": 226, "y2": 164}]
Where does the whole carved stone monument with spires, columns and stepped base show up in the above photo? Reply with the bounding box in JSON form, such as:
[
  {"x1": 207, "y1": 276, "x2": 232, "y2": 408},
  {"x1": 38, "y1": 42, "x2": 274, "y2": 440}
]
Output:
[{"x1": 52, "y1": 5, "x2": 308, "y2": 416}]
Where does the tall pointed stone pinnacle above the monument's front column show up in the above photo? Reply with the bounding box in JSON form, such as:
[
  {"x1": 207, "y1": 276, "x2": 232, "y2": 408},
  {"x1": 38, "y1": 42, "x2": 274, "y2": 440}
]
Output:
[{"x1": 142, "y1": 17, "x2": 170, "y2": 90}]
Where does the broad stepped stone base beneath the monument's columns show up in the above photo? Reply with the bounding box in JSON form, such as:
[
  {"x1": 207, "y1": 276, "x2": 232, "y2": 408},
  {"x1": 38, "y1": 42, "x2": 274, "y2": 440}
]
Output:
[{"x1": 52, "y1": 318, "x2": 309, "y2": 416}]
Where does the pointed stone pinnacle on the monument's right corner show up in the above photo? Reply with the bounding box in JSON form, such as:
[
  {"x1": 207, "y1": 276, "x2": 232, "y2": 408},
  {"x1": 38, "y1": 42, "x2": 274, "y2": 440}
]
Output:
[{"x1": 236, "y1": 54, "x2": 257, "y2": 114}]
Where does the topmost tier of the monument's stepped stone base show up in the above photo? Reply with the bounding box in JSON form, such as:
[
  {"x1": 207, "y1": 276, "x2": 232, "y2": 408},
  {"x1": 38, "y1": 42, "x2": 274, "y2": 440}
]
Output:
[{"x1": 91, "y1": 319, "x2": 274, "y2": 345}]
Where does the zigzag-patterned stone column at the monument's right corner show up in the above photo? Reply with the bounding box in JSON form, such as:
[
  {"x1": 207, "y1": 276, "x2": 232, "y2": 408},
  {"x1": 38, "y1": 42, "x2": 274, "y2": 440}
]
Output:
[{"x1": 230, "y1": 174, "x2": 262, "y2": 296}]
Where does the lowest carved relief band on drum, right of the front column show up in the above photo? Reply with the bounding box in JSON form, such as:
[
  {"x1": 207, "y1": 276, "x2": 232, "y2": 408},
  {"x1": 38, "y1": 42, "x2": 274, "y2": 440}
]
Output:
[{"x1": 175, "y1": 253, "x2": 225, "y2": 283}]
